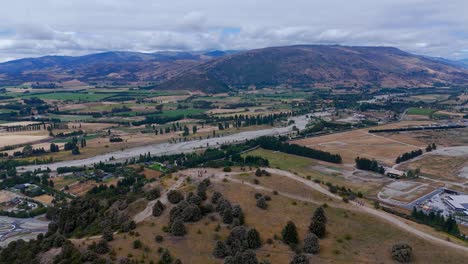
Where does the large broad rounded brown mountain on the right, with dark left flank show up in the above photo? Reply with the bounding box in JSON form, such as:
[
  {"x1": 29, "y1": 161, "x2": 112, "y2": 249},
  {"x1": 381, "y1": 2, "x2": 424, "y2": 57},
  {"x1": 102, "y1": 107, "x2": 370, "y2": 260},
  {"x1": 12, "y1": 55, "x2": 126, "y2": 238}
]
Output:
[{"x1": 163, "y1": 45, "x2": 468, "y2": 91}]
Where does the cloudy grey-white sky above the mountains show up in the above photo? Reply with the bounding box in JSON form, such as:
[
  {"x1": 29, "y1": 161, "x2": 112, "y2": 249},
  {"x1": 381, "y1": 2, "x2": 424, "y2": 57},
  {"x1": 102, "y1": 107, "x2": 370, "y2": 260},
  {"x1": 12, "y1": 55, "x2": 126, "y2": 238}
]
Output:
[{"x1": 0, "y1": 0, "x2": 468, "y2": 61}]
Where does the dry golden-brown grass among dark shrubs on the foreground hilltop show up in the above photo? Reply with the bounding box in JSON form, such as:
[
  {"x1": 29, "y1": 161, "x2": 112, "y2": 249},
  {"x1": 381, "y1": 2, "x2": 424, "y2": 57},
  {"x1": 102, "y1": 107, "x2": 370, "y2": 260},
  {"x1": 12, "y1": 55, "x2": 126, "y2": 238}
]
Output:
[{"x1": 83, "y1": 177, "x2": 467, "y2": 264}]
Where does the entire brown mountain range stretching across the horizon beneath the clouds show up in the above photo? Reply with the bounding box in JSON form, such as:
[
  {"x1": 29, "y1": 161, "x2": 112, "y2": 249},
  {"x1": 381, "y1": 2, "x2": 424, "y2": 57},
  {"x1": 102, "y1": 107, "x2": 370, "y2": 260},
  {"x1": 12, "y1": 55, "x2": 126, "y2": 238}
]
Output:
[{"x1": 0, "y1": 45, "x2": 468, "y2": 92}]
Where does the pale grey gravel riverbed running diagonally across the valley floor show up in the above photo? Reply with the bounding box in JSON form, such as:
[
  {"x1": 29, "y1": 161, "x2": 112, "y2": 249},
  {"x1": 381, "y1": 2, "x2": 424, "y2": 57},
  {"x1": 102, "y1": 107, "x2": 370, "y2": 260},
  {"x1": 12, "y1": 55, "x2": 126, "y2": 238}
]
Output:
[{"x1": 17, "y1": 115, "x2": 309, "y2": 172}]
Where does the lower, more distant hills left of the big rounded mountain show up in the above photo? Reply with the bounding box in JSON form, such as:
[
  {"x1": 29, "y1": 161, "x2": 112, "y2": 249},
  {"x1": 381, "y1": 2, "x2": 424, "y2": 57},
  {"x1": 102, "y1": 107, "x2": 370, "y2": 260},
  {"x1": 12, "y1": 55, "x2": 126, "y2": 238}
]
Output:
[{"x1": 0, "y1": 52, "x2": 209, "y2": 84}]
